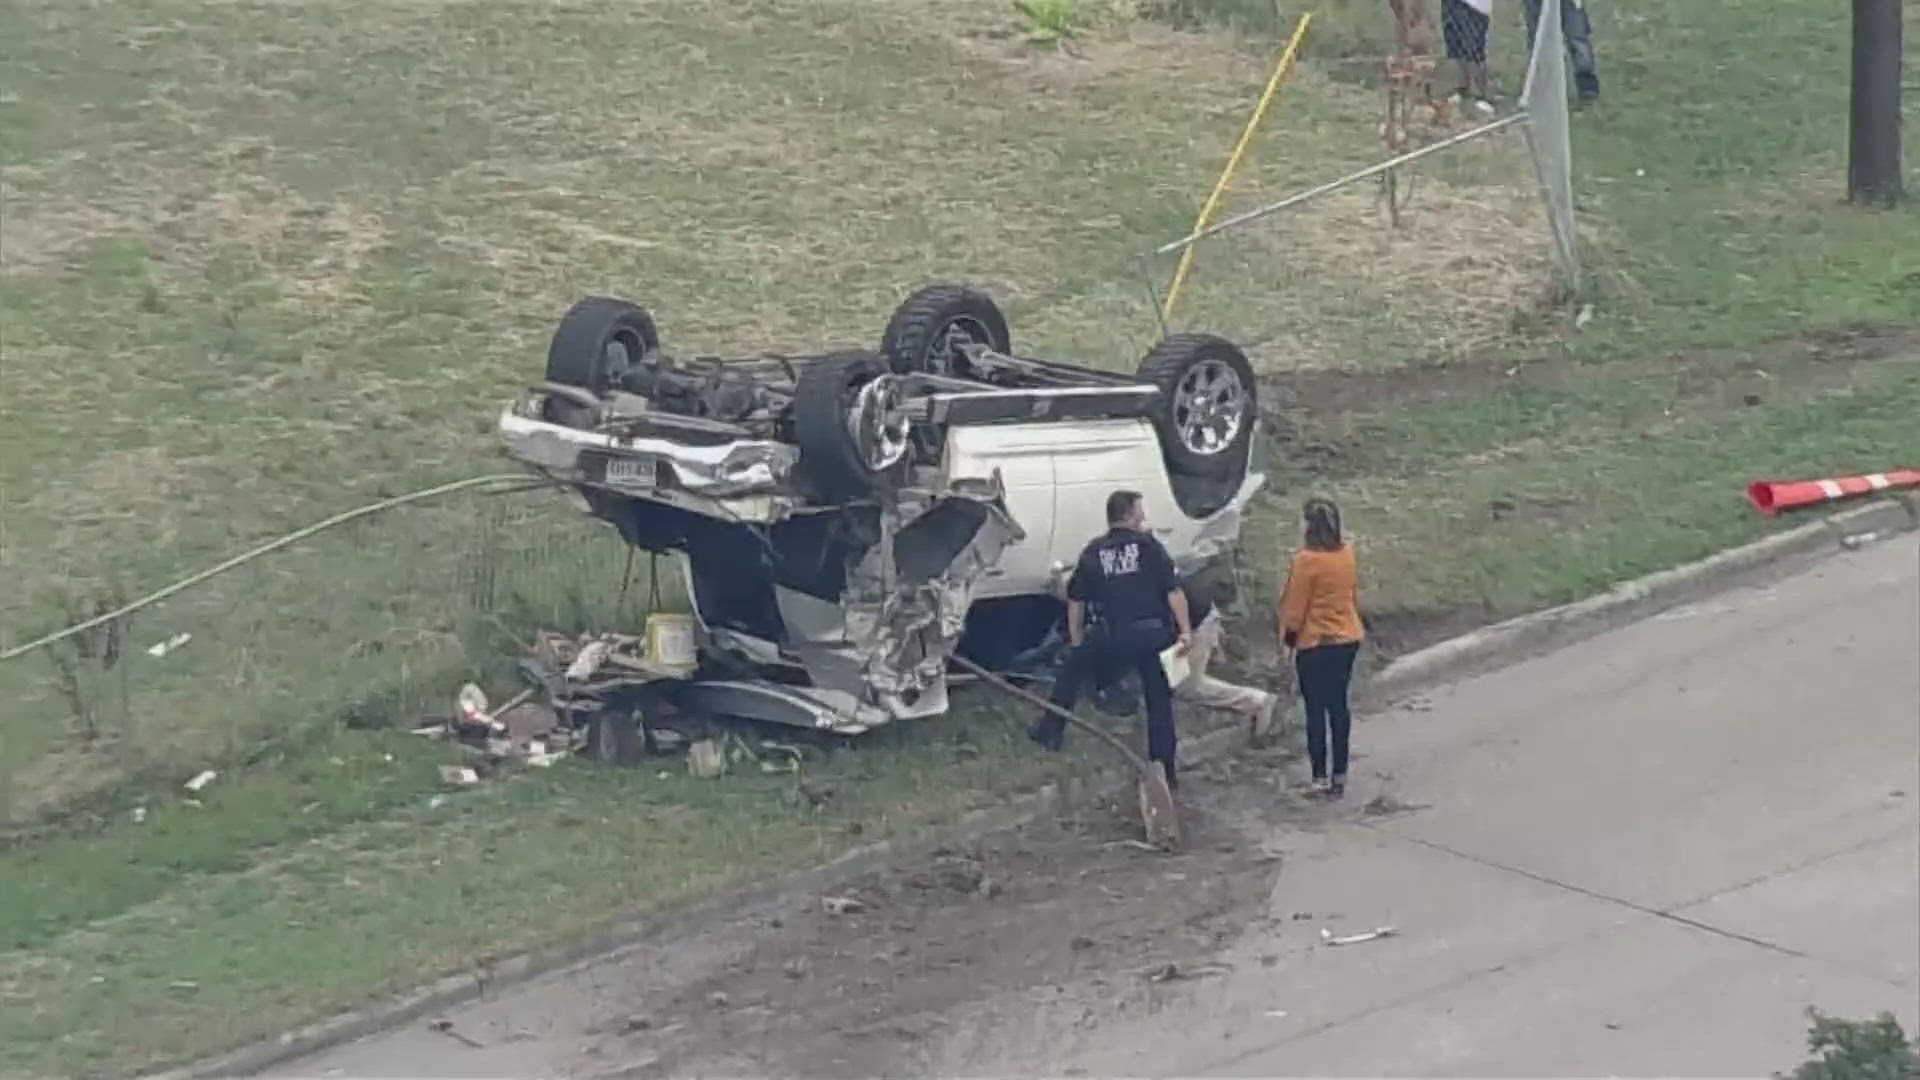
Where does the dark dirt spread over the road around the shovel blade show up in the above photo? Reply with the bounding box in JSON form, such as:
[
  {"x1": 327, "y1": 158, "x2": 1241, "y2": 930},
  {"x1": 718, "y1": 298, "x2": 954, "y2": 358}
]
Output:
[{"x1": 474, "y1": 753, "x2": 1325, "y2": 1076}]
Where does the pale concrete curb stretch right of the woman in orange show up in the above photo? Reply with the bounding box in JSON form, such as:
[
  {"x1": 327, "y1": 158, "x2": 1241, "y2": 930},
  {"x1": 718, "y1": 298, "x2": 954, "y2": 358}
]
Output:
[{"x1": 1367, "y1": 500, "x2": 1920, "y2": 694}]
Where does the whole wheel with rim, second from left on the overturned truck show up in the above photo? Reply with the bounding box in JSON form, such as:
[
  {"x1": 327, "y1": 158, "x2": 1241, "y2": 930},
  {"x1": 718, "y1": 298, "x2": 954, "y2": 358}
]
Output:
[{"x1": 793, "y1": 352, "x2": 912, "y2": 502}]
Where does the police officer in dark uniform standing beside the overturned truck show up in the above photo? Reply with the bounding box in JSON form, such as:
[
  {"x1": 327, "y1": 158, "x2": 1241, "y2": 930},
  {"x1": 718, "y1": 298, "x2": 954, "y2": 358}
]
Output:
[{"x1": 1027, "y1": 492, "x2": 1192, "y2": 784}]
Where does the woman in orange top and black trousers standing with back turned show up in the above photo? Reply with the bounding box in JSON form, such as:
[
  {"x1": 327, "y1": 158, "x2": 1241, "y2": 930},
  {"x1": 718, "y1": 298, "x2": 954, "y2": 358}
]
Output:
[{"x1": 1281, "y1": 498, "x2": 1367, "y2": 798}]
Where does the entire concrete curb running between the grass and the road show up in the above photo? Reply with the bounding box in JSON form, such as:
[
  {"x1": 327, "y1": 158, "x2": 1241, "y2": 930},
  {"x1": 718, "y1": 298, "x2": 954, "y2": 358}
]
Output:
[{"x1": 153, "y1": 500, "x2": 1920, "y2": 1080}]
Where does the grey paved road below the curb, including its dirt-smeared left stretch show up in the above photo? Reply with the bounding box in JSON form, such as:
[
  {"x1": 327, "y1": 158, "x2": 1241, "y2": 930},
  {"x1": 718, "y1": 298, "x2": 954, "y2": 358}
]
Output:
[{"x1": 282, "y1": 536, "x2": 1920, "y2": 1076}]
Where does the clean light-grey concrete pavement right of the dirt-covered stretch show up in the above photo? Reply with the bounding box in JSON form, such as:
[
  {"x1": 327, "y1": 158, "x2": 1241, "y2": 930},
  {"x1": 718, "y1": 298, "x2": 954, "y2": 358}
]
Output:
[{"x1": 1052, "y1": 536, "x2": 1920, "y2": 1076}]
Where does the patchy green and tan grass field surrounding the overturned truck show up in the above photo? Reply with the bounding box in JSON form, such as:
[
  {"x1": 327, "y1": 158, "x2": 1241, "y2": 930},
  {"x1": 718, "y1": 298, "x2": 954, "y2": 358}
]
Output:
[{"x1": 0, "y1": 0, "x2": 1920, "y2": 1074}]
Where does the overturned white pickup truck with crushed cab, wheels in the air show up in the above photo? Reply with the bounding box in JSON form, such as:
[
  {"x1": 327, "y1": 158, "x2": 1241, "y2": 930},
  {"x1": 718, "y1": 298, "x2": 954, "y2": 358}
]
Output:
[{"x1": 499, "y1": 284, "x2": 1263, "y2": 734}]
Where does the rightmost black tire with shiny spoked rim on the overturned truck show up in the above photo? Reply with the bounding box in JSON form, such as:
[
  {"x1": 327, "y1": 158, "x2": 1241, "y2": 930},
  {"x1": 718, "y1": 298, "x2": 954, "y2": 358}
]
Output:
[{"x1": 1137, "y1": 334, "x2": 1260, "y2": 480}]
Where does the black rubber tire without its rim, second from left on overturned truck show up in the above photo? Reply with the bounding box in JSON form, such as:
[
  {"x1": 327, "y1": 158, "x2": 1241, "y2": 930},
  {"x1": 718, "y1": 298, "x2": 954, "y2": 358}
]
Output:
[{"x1": 793, "y1": 352, "x2": 912, "y2": 502}]
